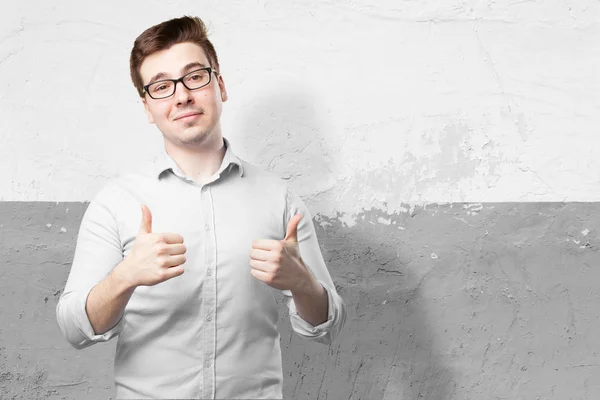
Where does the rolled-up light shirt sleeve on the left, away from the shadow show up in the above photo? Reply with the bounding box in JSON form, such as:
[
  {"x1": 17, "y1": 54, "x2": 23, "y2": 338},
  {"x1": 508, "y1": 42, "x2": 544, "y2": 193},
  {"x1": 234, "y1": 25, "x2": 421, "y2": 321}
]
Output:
[{"x1": 56, "y1": 186, "x2": 123, "y2": 349}]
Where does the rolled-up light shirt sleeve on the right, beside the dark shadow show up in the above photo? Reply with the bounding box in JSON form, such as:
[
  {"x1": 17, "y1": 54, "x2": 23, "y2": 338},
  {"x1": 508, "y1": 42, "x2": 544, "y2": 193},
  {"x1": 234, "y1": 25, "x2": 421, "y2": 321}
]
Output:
[{"x1": 283, "y1": 185, "x2": 346, "y2": 344}]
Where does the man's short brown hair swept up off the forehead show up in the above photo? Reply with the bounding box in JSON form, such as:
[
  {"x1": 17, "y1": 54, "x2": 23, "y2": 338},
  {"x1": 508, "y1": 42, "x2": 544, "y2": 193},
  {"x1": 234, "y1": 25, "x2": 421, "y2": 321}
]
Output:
[{"x1": 129, "y1": 15, "x2": 219, "y2": 97}]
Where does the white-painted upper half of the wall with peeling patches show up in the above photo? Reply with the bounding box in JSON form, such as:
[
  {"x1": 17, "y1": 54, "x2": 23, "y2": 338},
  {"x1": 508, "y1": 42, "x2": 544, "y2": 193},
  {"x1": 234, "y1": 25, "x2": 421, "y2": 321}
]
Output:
[{"x1": 0, "y1": 0, "x2": 600, "y2": 215}]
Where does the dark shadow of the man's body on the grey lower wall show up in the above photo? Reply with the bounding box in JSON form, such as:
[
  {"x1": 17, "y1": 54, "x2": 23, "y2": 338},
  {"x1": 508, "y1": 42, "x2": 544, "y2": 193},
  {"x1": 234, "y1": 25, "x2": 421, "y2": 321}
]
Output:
[{"x1": 280, "y1": 211, "x2": 456, "y2": 400}]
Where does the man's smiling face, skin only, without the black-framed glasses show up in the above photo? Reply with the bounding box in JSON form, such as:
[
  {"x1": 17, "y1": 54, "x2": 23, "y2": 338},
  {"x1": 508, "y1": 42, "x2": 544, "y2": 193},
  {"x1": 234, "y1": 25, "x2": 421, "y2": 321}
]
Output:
[{"x1": 140, "y1": 42, "x2": 227, "y2": 146}]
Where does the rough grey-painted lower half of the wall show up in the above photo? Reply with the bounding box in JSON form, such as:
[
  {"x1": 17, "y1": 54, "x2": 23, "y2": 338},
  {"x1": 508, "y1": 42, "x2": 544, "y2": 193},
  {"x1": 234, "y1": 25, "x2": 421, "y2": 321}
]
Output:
[{"x1": 0, "y1": 202, "x2": 600, "y2": 400}]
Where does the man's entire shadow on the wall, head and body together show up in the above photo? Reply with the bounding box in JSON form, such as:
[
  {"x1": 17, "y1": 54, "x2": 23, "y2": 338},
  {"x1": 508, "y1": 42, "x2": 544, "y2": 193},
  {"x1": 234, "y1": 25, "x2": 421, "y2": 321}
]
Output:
[{"x1": 233, "y1": 85, "x2": 455, "y2": 400}]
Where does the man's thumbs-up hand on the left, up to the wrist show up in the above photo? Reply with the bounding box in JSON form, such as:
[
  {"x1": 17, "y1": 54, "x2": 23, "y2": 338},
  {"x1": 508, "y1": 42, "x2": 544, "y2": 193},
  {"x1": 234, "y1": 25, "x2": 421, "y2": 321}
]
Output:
[{"x1": 115, "y1": 205, "x2": 186, "y2": 287}]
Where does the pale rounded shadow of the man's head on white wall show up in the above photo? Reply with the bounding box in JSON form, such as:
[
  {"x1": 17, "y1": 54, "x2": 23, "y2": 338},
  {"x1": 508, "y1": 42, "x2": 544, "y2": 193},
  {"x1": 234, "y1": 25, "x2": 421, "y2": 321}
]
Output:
[{"x1": 235, "y1": 76, "x2": 336, "y2": 200}]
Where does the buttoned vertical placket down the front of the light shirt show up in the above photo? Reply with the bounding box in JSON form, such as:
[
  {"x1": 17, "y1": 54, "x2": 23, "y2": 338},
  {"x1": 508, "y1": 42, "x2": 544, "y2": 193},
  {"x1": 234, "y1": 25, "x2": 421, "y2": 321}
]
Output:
[{"x1": 201, "y1": 184, "x2": 217, "y2": 399}]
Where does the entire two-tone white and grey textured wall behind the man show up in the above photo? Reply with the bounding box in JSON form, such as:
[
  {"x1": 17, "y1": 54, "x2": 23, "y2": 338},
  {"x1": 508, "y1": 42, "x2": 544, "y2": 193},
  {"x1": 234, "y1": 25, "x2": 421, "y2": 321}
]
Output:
[{"x1": 0, "y1": 0, "x2": 600, "y2": 400}]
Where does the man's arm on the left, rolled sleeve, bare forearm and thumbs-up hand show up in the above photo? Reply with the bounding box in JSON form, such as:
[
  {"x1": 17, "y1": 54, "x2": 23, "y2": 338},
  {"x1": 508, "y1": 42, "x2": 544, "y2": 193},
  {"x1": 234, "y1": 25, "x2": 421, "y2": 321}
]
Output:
[{"x1": 57, "y1": 198, "x2": 186, "y2": 348}]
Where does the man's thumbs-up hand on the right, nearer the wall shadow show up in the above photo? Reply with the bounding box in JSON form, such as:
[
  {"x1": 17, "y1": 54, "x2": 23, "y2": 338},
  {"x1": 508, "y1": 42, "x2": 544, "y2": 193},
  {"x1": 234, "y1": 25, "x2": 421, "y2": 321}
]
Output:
[{"x1": 250, "y1": 214, "x2": 312, "y2": 292}]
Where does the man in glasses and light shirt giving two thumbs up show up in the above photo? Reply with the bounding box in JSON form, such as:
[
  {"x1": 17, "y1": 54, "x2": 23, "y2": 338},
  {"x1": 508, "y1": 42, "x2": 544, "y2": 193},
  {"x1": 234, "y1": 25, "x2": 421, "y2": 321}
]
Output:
[{"x1": 57, "y1": 17, "x2": 345, "y2": 399}]
